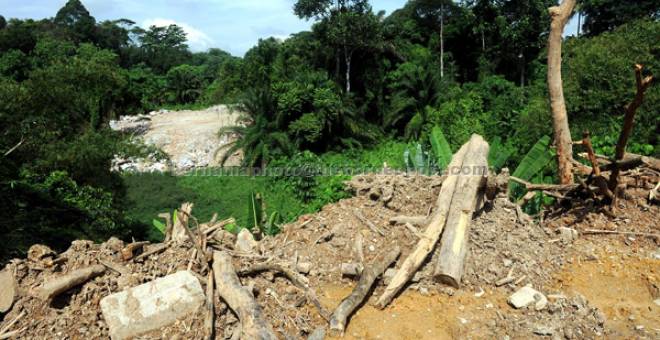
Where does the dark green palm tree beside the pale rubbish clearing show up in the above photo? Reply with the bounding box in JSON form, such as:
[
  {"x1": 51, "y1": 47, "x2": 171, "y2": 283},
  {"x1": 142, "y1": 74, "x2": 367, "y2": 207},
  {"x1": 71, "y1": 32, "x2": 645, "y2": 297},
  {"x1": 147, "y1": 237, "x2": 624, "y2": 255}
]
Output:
[{"x1": 218, "y1": 89, "x2": 294, "y2": 167}]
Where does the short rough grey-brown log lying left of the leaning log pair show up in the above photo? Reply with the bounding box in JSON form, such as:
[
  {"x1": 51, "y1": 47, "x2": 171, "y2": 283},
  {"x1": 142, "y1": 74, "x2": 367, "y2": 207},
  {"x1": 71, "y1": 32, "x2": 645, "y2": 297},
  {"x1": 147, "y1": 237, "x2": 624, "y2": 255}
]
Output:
[{"x1": 330, "y1": 247, "x2": 401, "y2": 334}]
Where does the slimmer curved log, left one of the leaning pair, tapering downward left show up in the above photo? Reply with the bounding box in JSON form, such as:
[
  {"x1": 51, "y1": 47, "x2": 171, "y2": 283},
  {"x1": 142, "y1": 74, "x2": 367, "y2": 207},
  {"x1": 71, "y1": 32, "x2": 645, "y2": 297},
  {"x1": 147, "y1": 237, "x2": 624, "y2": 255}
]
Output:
[{"x1": 376, "y1": 135, "x2": 472, "y2": 309}]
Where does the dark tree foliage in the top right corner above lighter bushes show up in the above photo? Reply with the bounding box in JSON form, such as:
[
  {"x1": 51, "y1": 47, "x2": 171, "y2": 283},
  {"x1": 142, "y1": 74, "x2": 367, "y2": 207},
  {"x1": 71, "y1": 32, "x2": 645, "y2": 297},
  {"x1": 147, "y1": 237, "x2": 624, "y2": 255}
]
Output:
[{"x1": 581, "y1": 0, "x2": 660, "y2": 36}]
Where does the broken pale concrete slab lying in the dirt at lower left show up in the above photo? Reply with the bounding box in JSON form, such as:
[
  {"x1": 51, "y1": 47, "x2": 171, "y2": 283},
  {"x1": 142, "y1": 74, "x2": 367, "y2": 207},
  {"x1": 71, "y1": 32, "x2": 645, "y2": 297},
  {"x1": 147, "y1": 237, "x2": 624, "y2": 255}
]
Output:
[{"x1": 101, "y1": 271, "x2": 205, "y2": 340}]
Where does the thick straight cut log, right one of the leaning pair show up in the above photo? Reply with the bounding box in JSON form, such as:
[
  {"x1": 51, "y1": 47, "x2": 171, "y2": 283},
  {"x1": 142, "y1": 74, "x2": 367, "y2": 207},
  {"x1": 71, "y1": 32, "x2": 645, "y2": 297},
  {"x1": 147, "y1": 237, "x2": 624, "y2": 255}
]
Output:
[{"x1": 434, "y1": 135, "x2": 489, "y2": 288}]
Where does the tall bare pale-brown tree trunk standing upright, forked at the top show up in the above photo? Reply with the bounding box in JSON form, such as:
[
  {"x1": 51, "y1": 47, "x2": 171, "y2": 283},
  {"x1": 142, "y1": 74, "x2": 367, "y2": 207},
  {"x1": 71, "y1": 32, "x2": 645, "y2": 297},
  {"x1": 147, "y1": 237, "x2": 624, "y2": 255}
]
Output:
[{"x1": 548, "y1": 0, "x2": 575, "y2": 184}]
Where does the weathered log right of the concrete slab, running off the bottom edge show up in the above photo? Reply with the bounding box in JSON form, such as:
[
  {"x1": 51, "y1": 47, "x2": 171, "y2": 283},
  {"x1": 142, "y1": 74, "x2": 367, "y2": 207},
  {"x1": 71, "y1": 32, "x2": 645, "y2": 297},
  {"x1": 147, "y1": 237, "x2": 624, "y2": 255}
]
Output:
[{"x1": 213, "y1": 251, "x2": 277, "y2": 340}]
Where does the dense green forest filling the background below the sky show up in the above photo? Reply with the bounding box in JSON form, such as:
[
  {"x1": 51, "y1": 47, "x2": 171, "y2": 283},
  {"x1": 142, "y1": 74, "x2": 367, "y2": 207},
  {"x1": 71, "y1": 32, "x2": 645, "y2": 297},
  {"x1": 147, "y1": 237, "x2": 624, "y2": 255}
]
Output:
[{"x1": 0, "y1": 0, "x2": 660, "y2": 258}]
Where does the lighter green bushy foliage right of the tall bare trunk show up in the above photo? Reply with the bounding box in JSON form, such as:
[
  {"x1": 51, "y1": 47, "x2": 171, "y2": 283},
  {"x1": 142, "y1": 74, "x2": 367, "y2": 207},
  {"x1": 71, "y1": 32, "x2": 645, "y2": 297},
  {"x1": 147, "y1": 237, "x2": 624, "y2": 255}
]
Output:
[{"x1": 564, "y1": 21, "x2": 660, "y2": 147}]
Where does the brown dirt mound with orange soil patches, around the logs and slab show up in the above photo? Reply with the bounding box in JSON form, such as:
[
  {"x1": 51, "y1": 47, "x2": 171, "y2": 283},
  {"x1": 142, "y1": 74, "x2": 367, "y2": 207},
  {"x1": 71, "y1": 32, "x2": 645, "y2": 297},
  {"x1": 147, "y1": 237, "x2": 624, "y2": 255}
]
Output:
[{"x1": 0, "y1": 175, "x2": 660, "y2": 339}]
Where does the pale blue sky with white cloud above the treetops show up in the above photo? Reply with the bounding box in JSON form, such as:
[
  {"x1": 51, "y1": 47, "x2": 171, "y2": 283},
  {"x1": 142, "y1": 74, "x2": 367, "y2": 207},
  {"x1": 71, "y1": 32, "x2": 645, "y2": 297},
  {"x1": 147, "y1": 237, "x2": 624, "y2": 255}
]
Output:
[{"x1": 0, "y1": 0, "x2": 577, "y2": 56}]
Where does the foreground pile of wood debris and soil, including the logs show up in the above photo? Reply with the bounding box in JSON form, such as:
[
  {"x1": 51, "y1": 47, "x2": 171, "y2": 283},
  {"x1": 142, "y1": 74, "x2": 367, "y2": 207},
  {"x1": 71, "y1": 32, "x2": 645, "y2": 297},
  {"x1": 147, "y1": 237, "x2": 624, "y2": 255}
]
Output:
[{"x1": 0, "y1": 136, "x2": 660, "y2": 339}]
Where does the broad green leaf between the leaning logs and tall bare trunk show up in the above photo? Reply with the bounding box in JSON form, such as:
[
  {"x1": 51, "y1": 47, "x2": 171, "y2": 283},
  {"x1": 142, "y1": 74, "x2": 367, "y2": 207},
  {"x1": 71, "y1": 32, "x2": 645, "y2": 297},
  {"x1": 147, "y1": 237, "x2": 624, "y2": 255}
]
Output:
[{"x1": 509, "y1": 136, "x2": 553, "y2": 200}]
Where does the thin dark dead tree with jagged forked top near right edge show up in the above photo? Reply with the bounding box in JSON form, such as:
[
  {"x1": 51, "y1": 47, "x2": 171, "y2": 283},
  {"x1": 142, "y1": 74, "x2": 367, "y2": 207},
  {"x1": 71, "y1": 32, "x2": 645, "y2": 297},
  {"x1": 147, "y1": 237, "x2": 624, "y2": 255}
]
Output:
[{"x1": 609, "y1": 64, "x2": 653, "y2": 190}]
